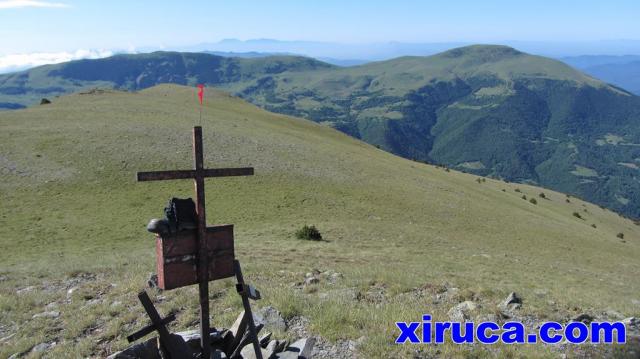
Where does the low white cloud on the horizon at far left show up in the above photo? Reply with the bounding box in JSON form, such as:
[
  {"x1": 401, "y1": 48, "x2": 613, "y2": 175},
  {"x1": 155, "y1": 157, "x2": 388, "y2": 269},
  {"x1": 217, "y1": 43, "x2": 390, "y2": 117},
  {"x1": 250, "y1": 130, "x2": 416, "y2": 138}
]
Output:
[{"x1": 0, "y1": 50, "x2": 113, "y2": 73}]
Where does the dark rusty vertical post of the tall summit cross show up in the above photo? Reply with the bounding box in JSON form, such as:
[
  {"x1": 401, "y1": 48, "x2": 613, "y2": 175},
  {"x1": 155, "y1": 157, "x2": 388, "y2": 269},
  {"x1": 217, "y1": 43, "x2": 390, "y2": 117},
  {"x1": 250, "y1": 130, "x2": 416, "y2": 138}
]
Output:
[{"x1": 193, "y1": 126, "x2": 211, "y2": 359}]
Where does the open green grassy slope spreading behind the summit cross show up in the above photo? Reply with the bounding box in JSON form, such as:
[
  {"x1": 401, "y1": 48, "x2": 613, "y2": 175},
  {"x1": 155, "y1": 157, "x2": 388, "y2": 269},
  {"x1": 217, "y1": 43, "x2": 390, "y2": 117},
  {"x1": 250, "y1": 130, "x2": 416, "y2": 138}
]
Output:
[{"x1": 0, "y1": 85, "x2": 640, "y2": 357}]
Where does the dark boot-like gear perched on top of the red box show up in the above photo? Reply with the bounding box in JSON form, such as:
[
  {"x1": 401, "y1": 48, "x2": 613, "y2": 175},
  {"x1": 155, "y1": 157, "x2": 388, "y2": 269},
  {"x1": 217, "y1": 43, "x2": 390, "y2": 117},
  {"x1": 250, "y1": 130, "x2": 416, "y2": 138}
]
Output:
[{"x1": 147, "y1": 198, "x2": 198, "y2": 236}]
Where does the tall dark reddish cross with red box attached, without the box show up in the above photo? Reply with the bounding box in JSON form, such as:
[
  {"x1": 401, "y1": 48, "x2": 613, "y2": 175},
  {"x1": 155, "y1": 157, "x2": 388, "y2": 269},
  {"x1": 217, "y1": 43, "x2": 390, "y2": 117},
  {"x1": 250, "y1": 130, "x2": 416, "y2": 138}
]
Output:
[{"x1": 137, "y1": 126, "x2": 253, "y2": 358}]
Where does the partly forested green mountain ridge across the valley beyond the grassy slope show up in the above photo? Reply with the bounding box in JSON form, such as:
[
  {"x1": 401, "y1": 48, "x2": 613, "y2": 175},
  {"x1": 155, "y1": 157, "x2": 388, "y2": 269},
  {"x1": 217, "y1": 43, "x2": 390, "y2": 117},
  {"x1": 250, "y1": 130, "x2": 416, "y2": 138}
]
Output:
[{"x1": 0, "y1": 45, "x2": 640, "y2": 218}]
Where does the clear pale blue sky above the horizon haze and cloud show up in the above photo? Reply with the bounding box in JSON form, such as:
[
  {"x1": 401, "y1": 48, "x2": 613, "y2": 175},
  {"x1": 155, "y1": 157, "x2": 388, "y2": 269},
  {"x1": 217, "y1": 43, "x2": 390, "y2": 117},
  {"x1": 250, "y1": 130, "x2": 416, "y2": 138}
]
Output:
[{"x1": 0, "y1": 0, "x2": 640, "y2": 54}]
